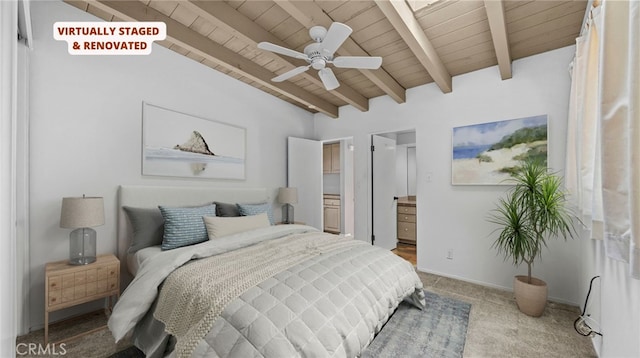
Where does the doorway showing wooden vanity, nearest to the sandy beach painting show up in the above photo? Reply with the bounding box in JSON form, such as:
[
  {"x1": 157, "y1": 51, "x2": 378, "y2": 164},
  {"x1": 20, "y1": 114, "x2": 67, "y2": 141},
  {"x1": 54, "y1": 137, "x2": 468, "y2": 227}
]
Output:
[{"x1": 370, "y1": 130, "x2": 418, "y2": 265}]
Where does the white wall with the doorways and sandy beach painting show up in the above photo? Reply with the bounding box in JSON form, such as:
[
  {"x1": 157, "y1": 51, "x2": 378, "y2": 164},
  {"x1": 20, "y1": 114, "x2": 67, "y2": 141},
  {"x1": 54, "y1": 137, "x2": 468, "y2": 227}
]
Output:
[{"x1": 315, "y1": 47, "x2": 583, "y2": 303}]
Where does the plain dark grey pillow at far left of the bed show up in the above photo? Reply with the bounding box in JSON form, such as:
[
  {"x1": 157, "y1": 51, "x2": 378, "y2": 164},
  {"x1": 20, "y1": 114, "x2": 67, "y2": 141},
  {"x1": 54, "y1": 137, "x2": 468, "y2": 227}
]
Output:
[{"x1": 122, "y1": 206, "x2": 164, "y2": 254}]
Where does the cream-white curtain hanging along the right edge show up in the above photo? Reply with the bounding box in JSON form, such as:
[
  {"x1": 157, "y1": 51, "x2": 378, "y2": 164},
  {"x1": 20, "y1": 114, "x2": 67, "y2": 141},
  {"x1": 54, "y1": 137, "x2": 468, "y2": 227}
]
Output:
[{"x1": 565, "y1": 0, "x2": 640, "y2": 279}]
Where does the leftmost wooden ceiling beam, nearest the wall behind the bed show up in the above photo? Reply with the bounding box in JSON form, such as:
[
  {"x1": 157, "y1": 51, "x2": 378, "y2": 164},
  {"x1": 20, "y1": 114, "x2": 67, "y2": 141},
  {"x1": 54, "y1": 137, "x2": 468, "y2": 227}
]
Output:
[{"x1": 76, "y1": 0, "x2": 338, "y2": 118}]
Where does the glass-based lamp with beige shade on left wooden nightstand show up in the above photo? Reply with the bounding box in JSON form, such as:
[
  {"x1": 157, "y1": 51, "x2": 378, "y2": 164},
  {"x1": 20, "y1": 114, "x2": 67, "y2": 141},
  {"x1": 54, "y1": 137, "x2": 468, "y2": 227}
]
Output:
[{"x1": 60, "y1": 195, "x2": 104, "y2": 265}]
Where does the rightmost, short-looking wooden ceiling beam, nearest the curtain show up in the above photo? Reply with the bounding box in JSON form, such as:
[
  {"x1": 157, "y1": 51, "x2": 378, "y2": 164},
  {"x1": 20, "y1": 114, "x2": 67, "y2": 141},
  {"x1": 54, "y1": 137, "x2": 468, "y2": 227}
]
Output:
[{"x1": 484, "y1": 0, "x2": 512, "y2": 80}]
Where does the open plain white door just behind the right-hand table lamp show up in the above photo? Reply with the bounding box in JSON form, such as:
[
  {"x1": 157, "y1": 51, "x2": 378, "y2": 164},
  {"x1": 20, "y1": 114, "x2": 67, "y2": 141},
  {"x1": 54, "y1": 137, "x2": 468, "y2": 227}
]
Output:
[{"x1": 287, "y1": 137, "x2": 322, "y2": 230}]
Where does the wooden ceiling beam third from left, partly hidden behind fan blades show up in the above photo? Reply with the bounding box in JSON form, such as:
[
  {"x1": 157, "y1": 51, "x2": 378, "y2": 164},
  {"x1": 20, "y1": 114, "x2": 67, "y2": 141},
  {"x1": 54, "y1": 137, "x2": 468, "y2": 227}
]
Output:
[{"x1": 275, "y1": 0, "x2": 406, "y2": 103}]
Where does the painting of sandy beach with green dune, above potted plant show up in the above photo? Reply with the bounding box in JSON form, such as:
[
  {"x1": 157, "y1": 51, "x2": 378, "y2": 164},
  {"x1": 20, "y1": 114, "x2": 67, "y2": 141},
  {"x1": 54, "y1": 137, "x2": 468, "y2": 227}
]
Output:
[{"x1": 451, "y1": 115, "x2": 548, "y2": 185}]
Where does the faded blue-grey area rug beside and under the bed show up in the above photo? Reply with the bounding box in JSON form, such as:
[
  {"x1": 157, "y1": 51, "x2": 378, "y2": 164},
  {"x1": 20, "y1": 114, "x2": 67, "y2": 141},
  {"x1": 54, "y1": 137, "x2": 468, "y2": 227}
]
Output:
[{"x1": 109, "y1": 291, "x2": 471, "y2": 358}]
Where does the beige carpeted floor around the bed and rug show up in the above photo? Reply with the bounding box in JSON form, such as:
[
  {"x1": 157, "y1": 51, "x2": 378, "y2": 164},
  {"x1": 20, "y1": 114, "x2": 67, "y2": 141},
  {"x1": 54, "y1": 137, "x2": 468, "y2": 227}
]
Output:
[{"x1": 17, "y1": 272, "x2": 597, "y2": 358}]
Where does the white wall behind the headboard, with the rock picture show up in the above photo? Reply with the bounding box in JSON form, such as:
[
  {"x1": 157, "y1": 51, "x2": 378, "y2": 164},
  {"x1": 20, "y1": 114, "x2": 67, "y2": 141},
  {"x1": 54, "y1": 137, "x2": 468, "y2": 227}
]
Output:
[{"x1": 30, "y1": 1, "x2": 313, "y2": 328}]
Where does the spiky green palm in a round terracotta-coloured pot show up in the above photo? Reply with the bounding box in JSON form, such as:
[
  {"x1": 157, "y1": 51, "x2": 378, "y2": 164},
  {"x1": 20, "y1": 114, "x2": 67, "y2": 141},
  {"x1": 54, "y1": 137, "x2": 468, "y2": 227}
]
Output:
[{"x1": 489, "y1": 160, "x2": 575, "y2": 317}]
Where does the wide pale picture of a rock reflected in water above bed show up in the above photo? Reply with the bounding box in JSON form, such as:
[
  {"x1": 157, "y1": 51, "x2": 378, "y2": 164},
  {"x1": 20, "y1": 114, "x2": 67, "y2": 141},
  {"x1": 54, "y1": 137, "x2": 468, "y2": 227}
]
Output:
[{"x1": 142, "y1": 103, "x2": 246, "y2": 180}]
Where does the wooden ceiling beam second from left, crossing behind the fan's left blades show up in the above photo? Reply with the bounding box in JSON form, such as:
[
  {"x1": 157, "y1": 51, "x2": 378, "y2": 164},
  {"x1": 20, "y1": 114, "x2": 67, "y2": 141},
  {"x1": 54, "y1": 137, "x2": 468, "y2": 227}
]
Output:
[{"x1": 180, "y1": 0, "x2": 369, "y2": 112}]
